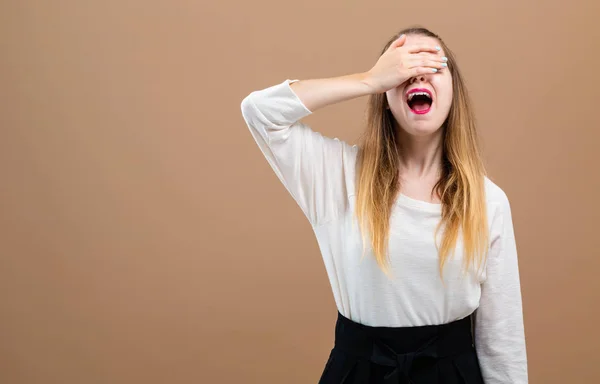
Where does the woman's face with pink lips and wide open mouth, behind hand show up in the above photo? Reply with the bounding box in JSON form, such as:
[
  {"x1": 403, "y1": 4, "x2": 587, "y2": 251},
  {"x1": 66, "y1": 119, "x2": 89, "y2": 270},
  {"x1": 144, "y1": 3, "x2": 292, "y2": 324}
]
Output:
[{"x1": 386, "y1": 35, "x2": 452, "y2": 136}]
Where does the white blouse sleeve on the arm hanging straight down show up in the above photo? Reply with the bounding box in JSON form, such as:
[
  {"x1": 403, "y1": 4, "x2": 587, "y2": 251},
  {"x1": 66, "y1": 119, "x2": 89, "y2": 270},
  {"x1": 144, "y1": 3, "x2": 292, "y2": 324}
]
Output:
[{"x1": 475, "y1": 193, "x2": 528, "y2": 384}]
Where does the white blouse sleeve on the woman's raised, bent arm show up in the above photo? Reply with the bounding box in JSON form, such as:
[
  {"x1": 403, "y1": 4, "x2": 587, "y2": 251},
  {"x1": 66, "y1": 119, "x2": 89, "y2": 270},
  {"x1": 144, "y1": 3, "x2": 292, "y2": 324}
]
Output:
[{"x1": 241, "y1": 80, "x2": 353, "y2": 226}]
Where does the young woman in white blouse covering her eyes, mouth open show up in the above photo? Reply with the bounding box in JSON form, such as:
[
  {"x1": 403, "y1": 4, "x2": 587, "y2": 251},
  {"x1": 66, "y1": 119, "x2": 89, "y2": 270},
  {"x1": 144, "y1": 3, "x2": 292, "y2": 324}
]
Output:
[{"x1": 241, "y1": 28, "x2": 527, "y2": 384}]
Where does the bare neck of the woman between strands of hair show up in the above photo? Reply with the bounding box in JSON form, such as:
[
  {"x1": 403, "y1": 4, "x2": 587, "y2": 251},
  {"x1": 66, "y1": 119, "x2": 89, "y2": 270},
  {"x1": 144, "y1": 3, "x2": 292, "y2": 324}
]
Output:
[{"x1": 398, "y1": 129, "x2": 443, "y2": 178}]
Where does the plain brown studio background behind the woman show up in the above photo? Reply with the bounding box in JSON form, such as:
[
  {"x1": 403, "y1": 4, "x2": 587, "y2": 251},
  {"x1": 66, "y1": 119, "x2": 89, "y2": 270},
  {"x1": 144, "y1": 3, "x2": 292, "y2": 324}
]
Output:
[{"x1": 0, "y1": 0, "x2": 600, "y2": 384}]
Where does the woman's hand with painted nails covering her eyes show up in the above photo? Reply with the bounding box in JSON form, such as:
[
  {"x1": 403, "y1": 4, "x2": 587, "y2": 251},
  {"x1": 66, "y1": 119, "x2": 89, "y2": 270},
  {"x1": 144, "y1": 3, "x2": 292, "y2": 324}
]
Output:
[{"x1": 366, "y1": 35, "x2": 447, "y2": 93}]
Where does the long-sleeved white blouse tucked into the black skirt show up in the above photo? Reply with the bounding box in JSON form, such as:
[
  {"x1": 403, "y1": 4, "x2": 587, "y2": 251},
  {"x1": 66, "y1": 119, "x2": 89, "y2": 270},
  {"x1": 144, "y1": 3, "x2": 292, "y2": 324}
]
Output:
[{"x1": 241, "y1": 80, "x2": 527, "y2": 384}]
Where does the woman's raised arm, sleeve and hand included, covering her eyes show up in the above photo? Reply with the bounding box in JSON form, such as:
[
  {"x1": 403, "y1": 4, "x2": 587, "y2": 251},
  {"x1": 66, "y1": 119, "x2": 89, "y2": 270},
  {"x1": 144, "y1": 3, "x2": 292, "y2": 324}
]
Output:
[{"x1": 241, "y1": 37, "x2": 443, "y2": 226}]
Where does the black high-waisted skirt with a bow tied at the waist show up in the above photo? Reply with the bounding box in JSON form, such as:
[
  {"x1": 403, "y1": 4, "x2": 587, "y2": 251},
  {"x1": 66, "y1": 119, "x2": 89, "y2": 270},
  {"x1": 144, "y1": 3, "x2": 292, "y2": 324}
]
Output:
[{"x1": 319, "y1": 313, "x2": 483, "y2": 384}]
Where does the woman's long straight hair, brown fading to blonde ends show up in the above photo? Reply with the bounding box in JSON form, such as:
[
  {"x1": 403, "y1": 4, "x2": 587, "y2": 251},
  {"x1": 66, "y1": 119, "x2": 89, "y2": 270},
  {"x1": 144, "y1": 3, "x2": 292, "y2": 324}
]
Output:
[{"x1": 356, "y1": 28, "x2": 489, "y2": 275}]
